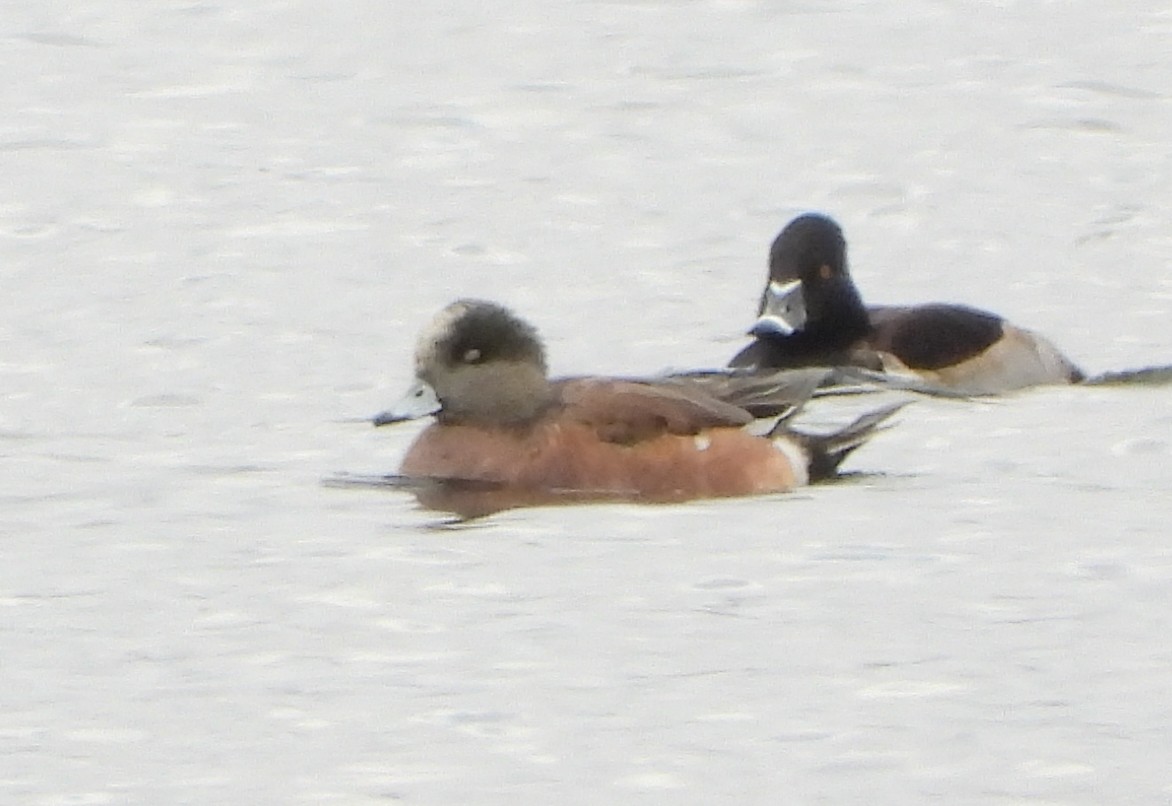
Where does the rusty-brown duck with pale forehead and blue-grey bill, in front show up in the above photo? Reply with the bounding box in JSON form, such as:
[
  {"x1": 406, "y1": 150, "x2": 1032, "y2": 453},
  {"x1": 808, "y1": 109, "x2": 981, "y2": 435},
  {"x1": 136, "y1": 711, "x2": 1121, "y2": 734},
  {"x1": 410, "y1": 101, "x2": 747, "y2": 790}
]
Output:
[{"x1": 374, "y1": 300, "x2": 899, "y2": 518}]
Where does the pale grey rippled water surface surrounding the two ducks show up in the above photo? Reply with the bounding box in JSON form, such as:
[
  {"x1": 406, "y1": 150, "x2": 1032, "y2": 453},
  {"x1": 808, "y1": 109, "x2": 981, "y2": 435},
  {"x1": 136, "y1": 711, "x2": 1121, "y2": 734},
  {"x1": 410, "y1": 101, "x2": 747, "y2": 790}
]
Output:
[{"x1": 0, "y1": 0, "x2": 1172, "y2": 805}]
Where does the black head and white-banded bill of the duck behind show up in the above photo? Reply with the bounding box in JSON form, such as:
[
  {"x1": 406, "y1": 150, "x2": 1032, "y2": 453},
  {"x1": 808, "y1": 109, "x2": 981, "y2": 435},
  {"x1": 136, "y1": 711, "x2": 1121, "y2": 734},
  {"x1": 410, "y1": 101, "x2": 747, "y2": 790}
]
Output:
[{"x1": 750, "y1": 213, "x2": 865, "y2": 337}]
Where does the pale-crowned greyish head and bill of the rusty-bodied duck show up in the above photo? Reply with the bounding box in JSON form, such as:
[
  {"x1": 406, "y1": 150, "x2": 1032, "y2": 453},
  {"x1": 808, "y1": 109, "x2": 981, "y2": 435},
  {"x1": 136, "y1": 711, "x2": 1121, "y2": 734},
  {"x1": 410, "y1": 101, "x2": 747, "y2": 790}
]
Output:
[{"x1": 374, "y1": 300, "x2": 551, "y2": 425}]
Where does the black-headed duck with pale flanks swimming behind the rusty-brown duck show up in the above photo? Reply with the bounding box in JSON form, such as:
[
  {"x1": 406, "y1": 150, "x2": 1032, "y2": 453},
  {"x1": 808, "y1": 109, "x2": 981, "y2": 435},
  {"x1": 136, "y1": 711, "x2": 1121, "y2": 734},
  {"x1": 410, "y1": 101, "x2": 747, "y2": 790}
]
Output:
[{"x1": 729, "y1": 213, "x2": 1084, "y2": 395}]
